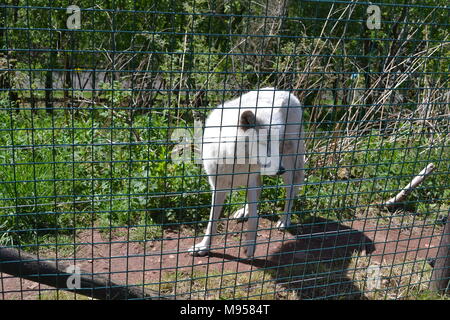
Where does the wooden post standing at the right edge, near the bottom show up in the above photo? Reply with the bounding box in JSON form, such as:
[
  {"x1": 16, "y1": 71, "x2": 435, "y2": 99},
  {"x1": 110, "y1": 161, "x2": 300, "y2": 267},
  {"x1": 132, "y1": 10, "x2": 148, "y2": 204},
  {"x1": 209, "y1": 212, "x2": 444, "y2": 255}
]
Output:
[{"x1": 430, "y1": 213, "x2": 450, "y2": 293}]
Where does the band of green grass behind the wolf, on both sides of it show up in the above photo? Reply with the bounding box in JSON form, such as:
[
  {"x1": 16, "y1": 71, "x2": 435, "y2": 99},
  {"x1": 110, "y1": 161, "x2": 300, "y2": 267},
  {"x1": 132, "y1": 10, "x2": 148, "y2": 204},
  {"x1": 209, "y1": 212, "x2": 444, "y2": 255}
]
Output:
[{"x1": 0, "y1": 109, "x2": 450, "y2": 248}]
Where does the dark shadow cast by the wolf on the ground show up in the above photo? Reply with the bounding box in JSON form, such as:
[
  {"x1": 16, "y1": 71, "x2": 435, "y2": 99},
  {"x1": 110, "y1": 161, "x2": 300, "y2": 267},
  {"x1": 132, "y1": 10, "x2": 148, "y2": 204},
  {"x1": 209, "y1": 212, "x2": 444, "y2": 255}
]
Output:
[{"x1": 210, "y1": 218, "x2": 375, "y2": 299}]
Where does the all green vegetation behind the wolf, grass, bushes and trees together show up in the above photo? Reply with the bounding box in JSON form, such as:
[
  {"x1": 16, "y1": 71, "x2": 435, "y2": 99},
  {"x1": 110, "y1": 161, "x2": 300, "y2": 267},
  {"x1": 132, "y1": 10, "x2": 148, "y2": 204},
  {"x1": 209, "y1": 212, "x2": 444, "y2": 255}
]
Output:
[{"x1": 0, "y1": 0, "x2": 450, "y2": 299}]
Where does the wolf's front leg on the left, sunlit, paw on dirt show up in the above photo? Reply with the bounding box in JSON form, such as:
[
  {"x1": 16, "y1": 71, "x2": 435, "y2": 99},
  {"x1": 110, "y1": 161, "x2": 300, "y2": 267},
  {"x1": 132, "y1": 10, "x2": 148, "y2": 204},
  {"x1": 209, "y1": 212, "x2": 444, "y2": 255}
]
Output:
[{"x1": 189, "y1": 190, "x2": 228, "y2": 256}]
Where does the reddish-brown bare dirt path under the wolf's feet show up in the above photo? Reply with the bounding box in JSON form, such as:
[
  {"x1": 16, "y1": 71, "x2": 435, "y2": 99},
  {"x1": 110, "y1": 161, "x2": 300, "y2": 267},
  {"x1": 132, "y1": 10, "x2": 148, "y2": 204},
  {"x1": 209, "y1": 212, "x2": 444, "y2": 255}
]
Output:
[{"x1": 0, "y1": 215, "x2": 440, "y2": 299}]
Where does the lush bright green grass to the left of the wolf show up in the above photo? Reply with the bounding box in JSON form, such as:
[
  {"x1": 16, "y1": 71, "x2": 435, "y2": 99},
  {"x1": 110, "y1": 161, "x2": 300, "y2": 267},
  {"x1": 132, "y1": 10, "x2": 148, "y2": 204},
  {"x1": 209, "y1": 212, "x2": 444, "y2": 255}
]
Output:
[{"x1": 0, "y1": 110, "x2": 209, "y2": 242}]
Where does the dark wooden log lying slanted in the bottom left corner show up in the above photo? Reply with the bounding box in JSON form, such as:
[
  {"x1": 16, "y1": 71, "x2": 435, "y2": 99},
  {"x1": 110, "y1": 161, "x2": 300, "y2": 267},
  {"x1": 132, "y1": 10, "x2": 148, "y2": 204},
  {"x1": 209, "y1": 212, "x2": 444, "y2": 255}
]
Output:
[{"x1": 0, "y1": 247, "x2": 169, "y2": 300}]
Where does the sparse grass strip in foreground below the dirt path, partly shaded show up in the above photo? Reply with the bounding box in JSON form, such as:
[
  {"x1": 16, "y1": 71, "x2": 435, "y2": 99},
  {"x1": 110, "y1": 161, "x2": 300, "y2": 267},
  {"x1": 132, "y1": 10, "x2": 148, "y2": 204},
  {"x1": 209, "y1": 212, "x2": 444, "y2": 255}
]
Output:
[{"x1": 146, "y1": 254, "x2": 450, "y2": 300}]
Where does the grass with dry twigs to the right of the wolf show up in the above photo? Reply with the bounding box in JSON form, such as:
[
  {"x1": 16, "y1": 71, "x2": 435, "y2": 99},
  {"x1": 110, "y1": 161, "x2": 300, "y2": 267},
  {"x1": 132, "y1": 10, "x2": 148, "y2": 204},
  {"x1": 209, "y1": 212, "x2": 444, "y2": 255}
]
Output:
[{"x1": 302, "y1": 127, "x2": 450, "y2": 224}]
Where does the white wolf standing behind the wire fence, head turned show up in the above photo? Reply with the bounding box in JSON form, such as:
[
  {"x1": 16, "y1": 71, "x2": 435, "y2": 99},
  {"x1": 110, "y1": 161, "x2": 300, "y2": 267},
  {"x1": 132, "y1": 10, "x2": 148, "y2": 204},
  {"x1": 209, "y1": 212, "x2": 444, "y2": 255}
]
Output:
[{"x1": 189, "y1": 88, "x2": 305, "y2": 257}]
